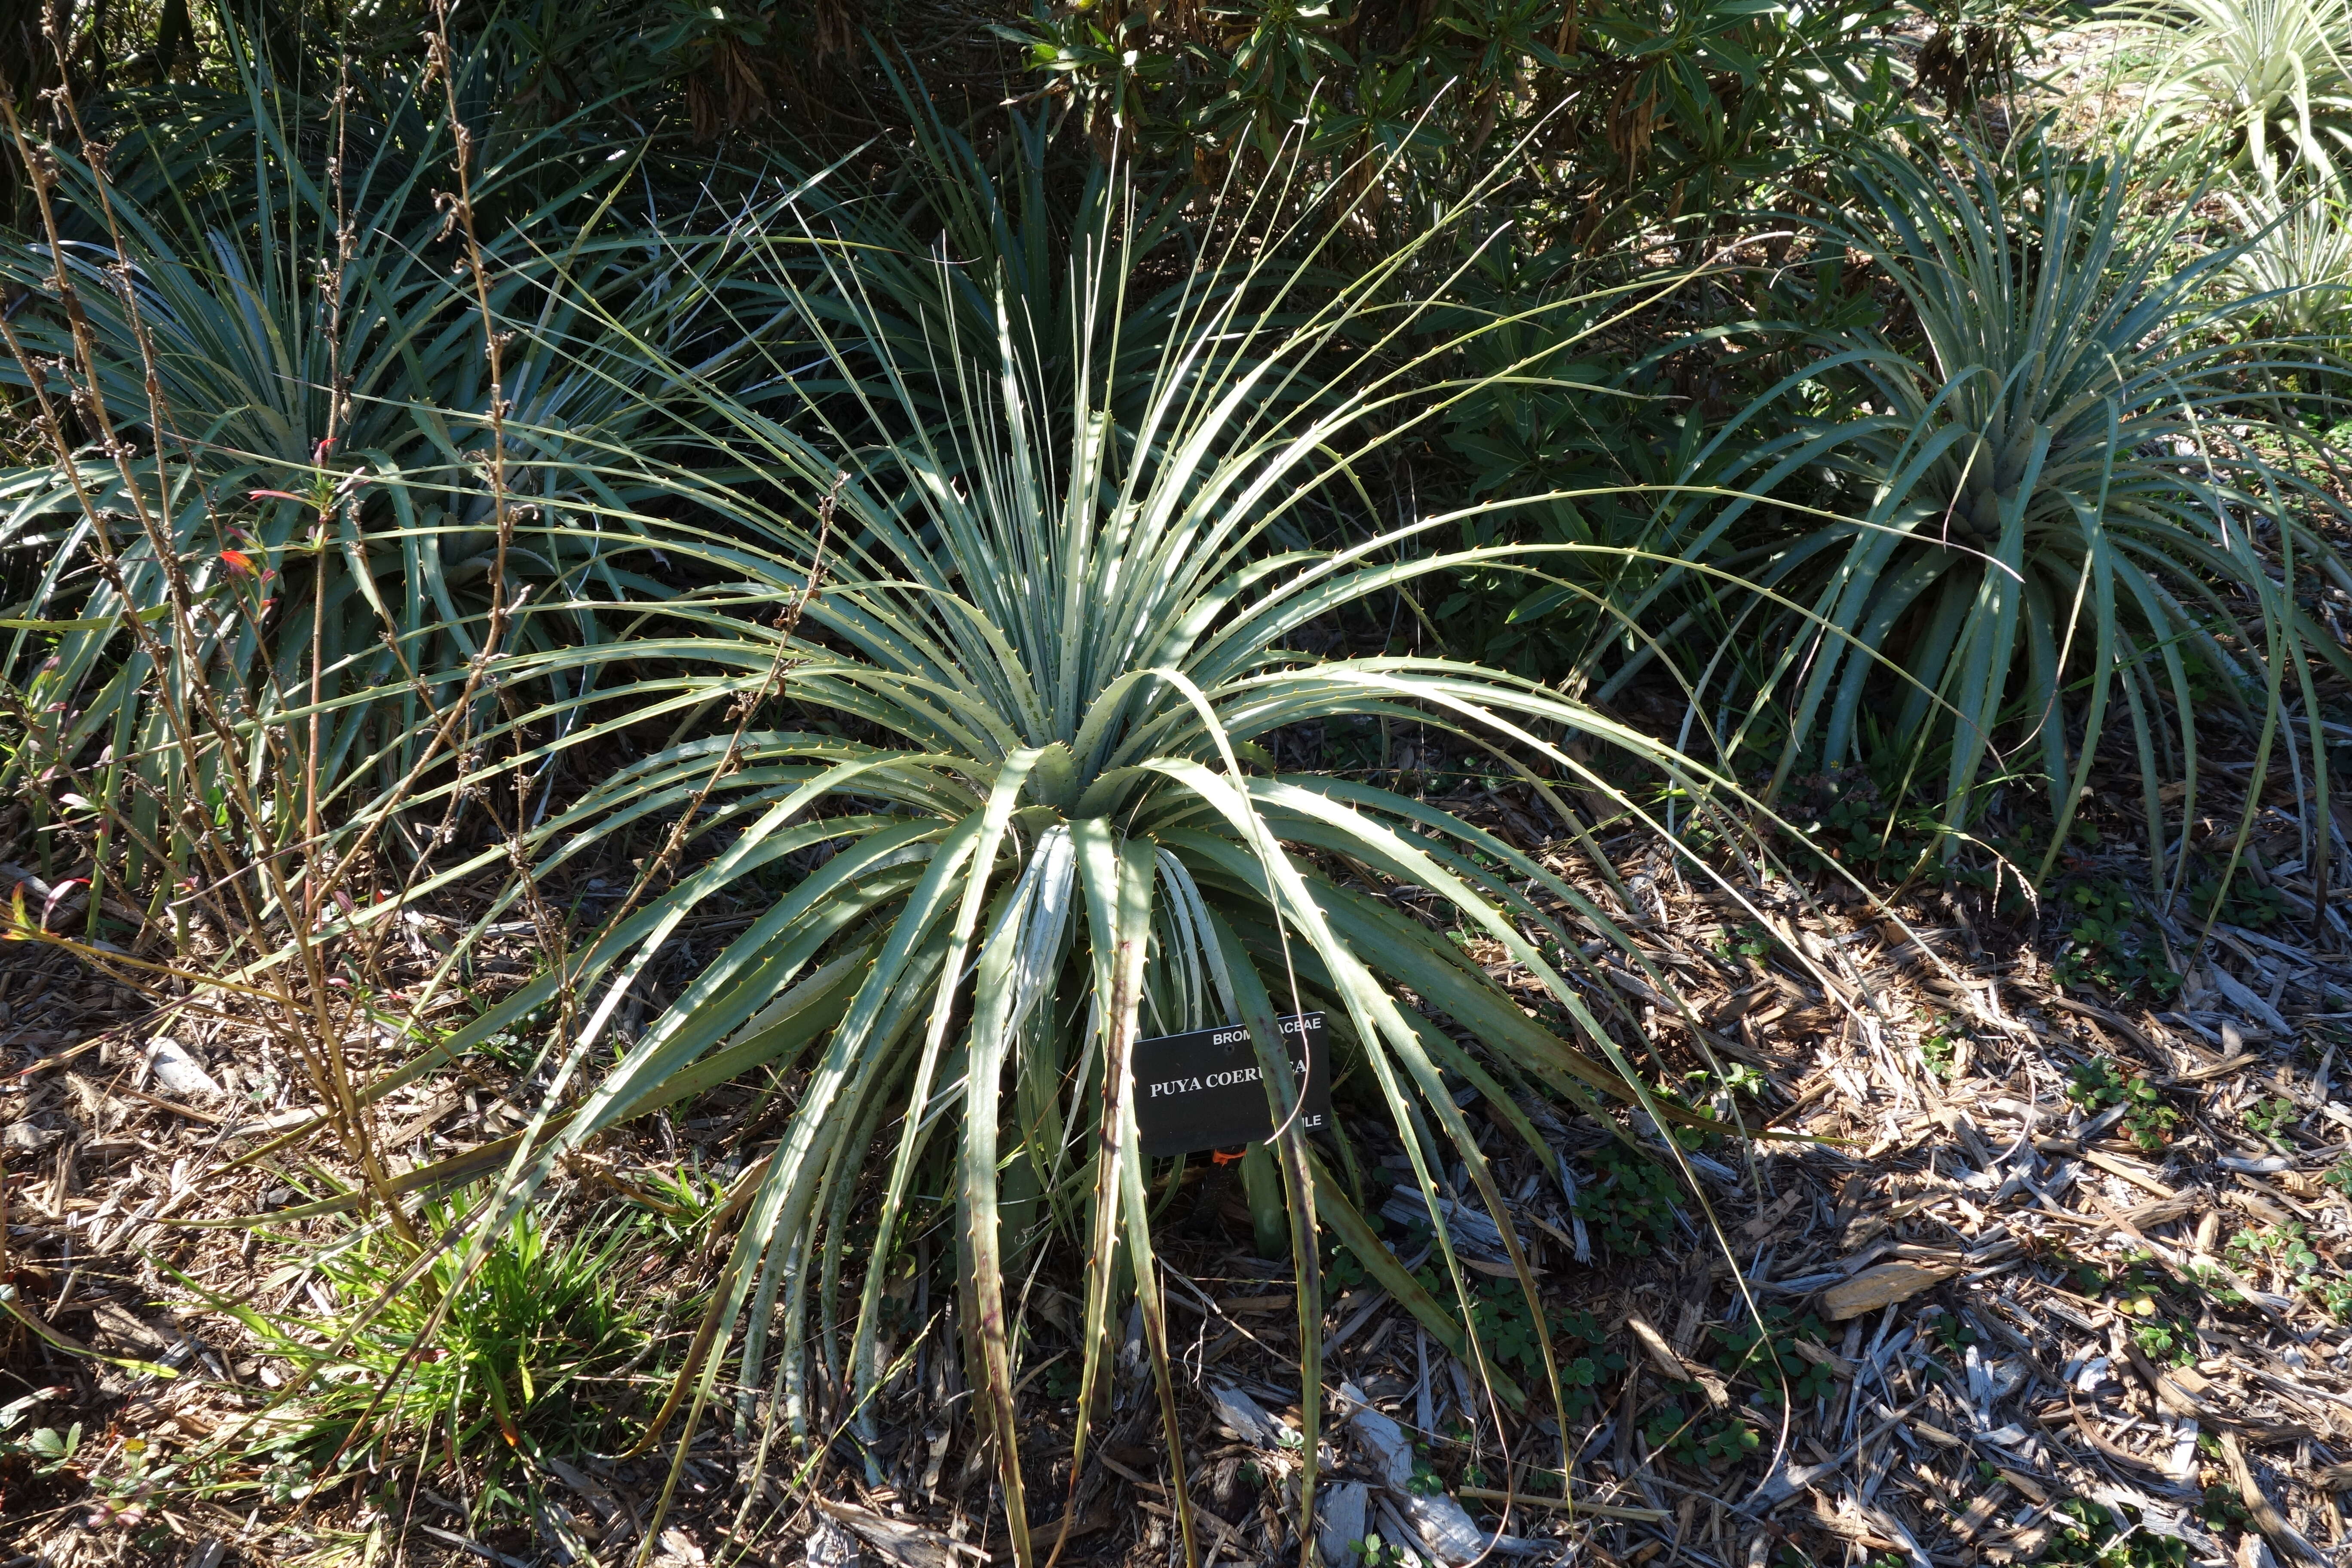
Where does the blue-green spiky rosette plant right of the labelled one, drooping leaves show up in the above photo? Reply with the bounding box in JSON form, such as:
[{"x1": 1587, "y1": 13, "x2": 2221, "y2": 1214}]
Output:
[{"x1": 1686, "y1": 141, "x2": 2352, "y2": 882}]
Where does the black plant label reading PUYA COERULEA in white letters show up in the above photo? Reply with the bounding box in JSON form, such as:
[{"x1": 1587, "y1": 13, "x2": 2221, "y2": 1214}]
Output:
[{"x1": 1134, "y1": 1013, "x2": 1331, "y2": 1157}]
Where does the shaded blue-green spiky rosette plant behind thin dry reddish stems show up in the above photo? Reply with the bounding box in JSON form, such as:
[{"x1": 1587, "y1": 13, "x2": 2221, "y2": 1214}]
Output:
[{"x1": 0, "y1": 52, "x2": 790, "y2": 912}]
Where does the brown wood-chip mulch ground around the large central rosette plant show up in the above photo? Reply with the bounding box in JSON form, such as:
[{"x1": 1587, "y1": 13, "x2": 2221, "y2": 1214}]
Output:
[{"x1": 0, "y1": 795, "x2": 2352, "y2": 1568}]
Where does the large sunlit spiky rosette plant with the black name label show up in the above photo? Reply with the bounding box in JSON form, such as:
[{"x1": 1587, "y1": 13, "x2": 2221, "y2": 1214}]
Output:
[{"x1": 348, "y1": 153, "x2": 1750, "y2": 1561}]
